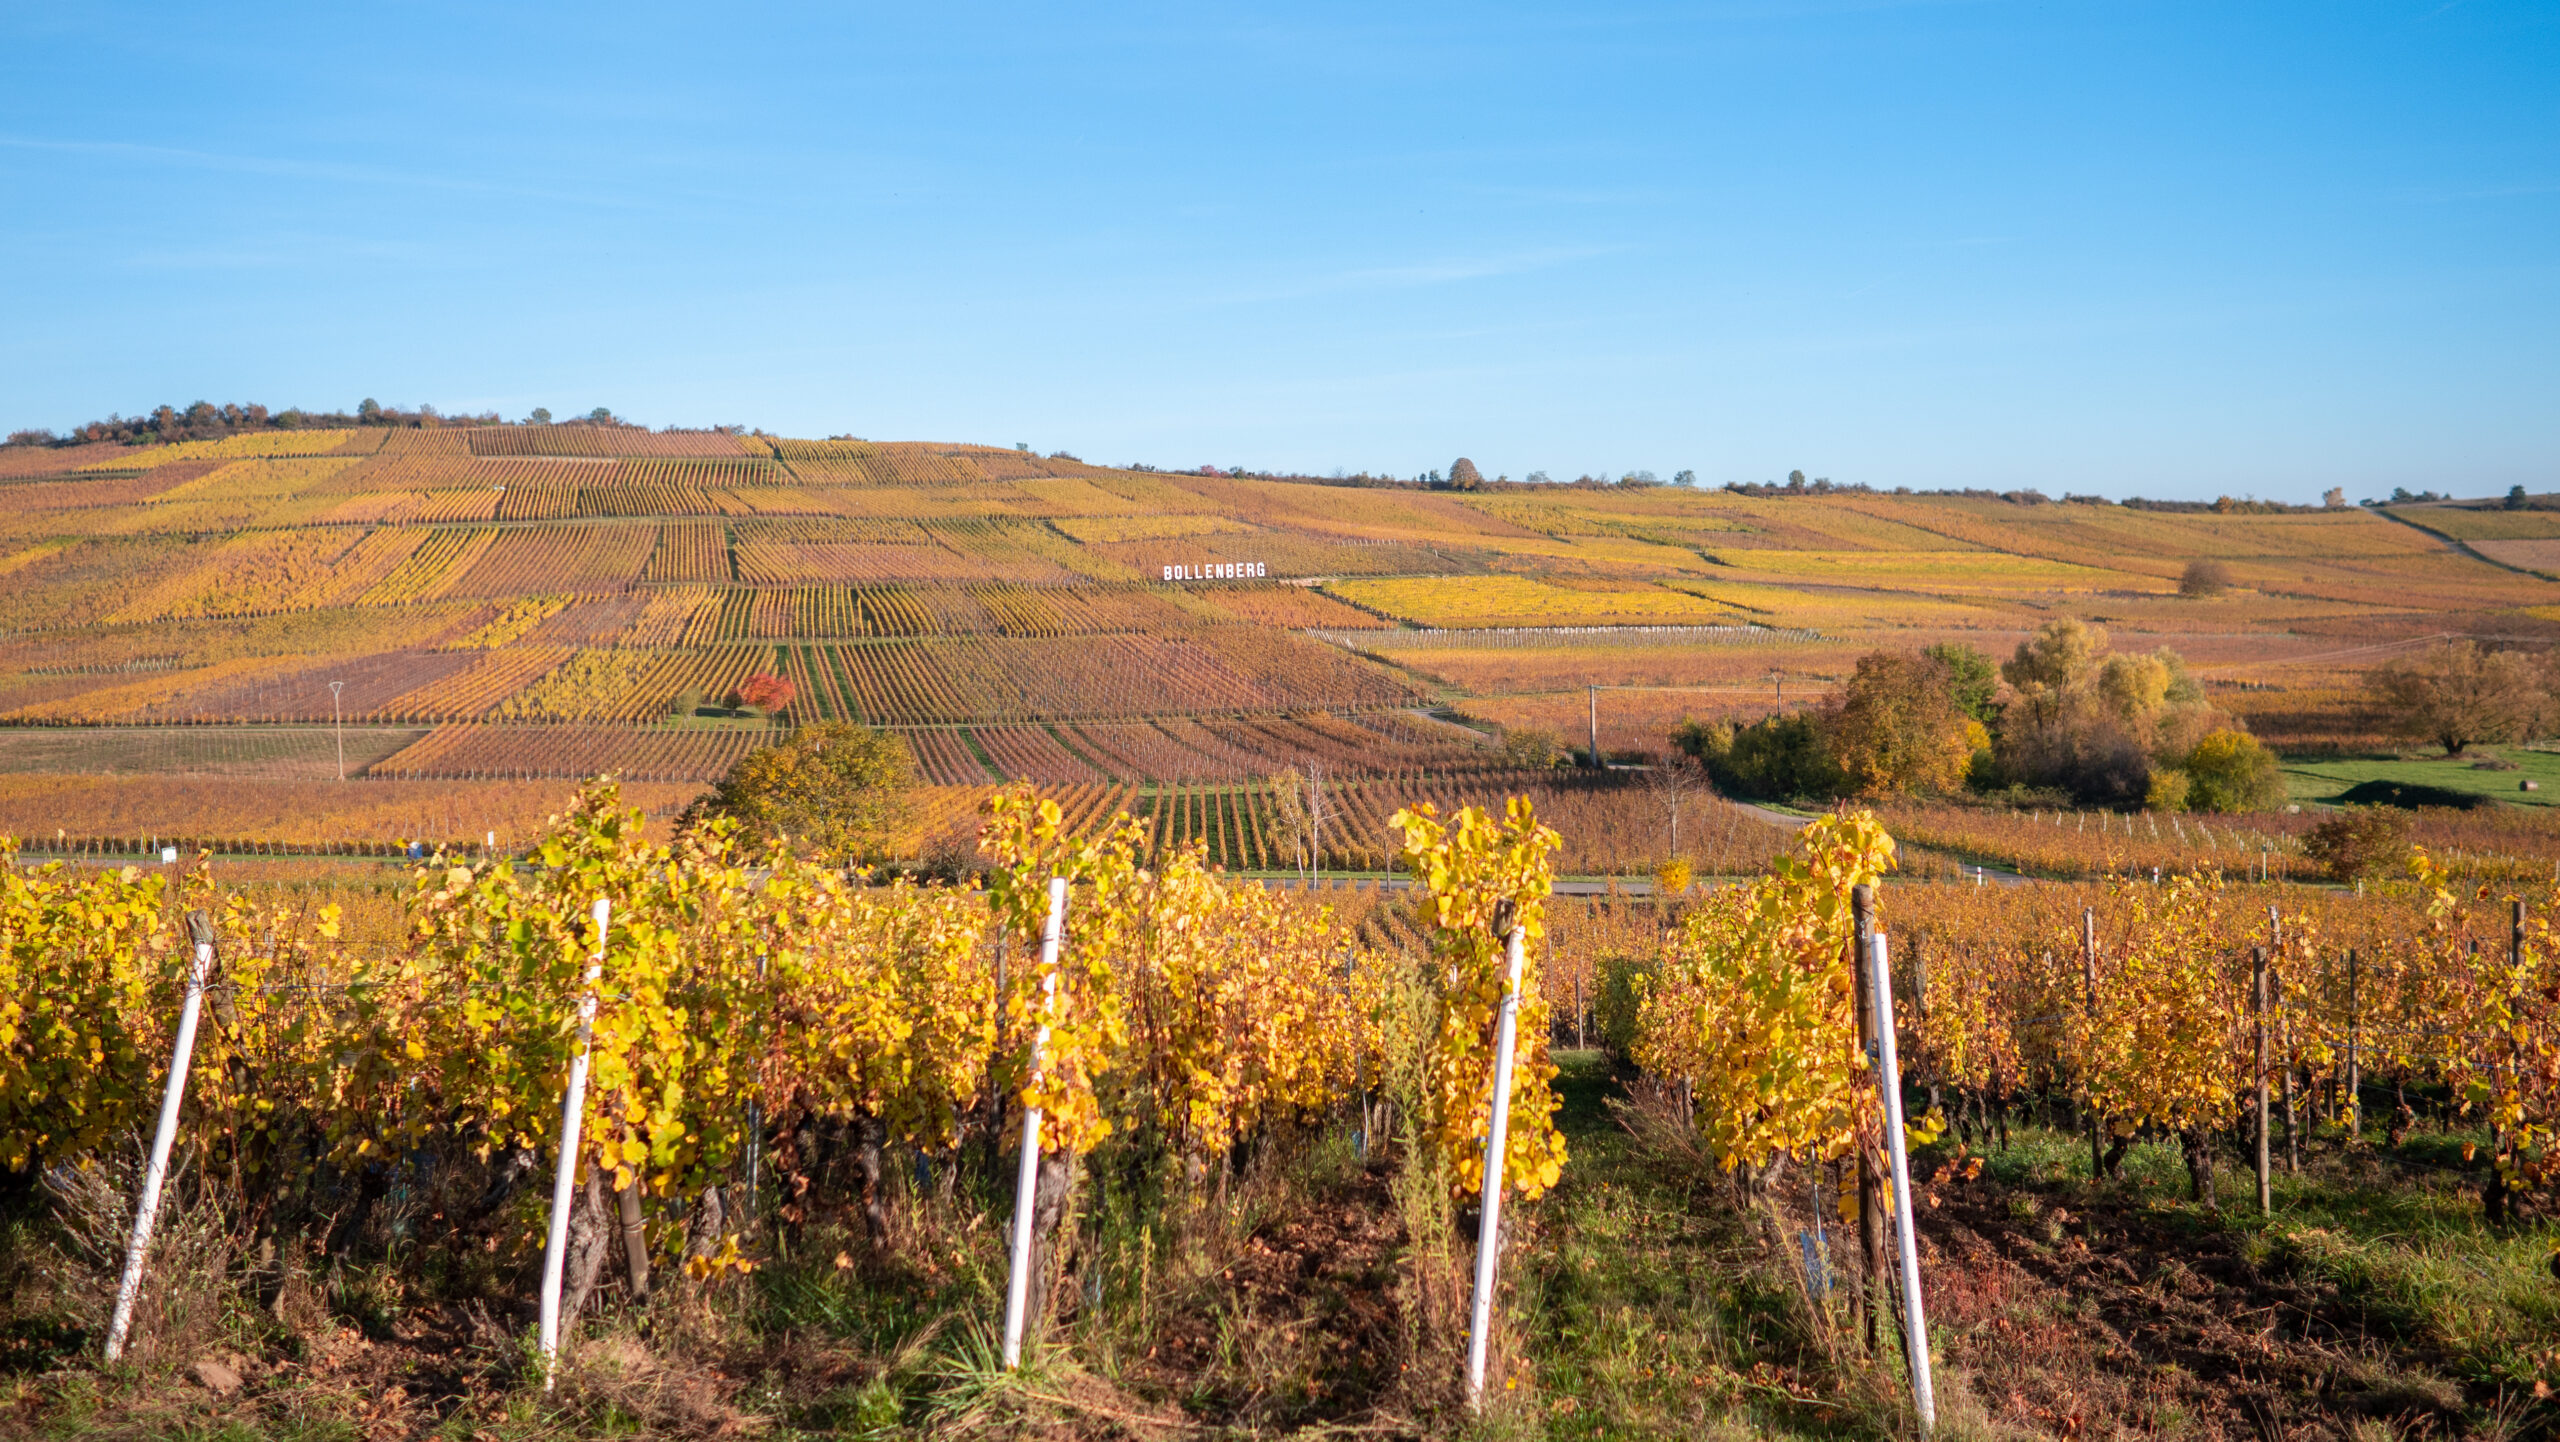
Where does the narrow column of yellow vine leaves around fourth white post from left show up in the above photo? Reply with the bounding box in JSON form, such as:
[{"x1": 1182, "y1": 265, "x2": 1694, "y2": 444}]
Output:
[{"x1": 1390, "y1": 797, "x2": 1564, "y2": 1196}]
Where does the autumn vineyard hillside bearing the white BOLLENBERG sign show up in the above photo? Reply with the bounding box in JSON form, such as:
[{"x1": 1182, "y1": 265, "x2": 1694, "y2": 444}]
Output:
[{"x1": 0, "y1": 425, "x2": 2560, "y2": 866}]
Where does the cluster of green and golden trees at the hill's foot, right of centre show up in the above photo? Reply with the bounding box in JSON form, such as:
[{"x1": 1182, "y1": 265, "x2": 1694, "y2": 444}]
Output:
[{"x1": 1672, "y1": 620, "x2": 2284, "y2": 812}]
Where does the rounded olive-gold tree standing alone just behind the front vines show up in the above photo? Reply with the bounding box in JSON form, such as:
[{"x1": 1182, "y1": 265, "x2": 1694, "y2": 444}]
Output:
[{"x1": 689, "y1": 722, "x2": 914, "y2": 861}]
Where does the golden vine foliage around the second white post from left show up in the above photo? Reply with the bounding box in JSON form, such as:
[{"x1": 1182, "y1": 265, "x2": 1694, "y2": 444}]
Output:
[{"x1": 346, "y1": 781, "x2": 755, "y2": 1196}]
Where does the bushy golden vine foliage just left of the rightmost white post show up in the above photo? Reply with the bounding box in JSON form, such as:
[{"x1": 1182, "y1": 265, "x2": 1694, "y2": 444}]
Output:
[{"x1": 1636, "y1": 812, "x2": 1894, "y2": 1171}]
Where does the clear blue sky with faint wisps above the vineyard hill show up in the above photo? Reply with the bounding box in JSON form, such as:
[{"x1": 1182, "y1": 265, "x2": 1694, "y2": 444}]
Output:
[{"x1": 0, "y1": 0, "x2": 2560, "y2": 499}]
